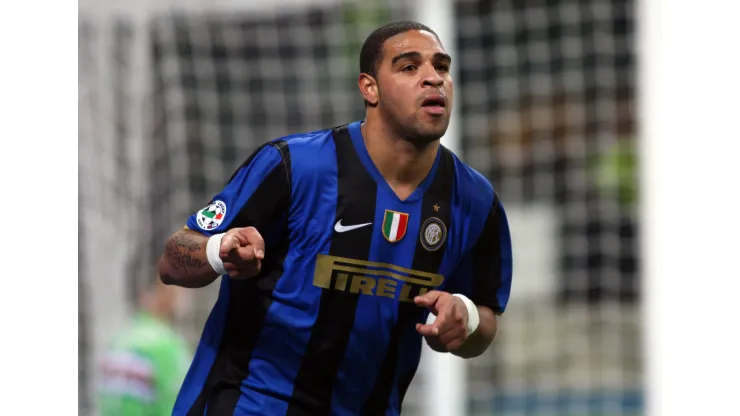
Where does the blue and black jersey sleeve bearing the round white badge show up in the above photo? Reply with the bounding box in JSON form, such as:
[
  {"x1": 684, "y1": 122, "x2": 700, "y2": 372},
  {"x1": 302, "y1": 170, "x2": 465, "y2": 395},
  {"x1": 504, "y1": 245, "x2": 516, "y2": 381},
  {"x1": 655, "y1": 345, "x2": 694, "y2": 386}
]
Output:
[{"x1": 187, "y1": 142, "x2": 290, "y2": 236}]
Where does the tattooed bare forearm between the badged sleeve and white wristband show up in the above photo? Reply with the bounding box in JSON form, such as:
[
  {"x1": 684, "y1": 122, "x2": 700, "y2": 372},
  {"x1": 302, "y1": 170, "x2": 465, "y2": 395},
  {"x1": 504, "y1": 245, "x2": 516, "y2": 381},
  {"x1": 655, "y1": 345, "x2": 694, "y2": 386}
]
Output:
[{"x1": 159, "y1": 229, "x2": 218, "y2": 288}]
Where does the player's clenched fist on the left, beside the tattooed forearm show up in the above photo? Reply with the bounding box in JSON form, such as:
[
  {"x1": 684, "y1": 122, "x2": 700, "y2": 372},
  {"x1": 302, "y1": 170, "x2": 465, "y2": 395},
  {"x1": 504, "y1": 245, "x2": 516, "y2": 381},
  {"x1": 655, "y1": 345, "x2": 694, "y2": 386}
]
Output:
[{"x1": 219, "y1": 227, "x2": 265, "y2": 279}]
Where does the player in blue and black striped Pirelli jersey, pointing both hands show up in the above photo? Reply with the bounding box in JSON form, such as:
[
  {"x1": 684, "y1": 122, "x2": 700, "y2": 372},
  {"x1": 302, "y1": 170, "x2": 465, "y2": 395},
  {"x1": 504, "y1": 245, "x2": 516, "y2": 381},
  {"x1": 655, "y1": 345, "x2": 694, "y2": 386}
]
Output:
[{"x1": 159, "y1": 22, "x2": 512, "y2": 416}]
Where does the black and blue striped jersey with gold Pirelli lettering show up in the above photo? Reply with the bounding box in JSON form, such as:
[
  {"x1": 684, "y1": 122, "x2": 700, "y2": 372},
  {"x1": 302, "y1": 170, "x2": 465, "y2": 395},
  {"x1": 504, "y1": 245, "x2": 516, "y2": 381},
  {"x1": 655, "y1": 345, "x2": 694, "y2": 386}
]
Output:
[{"x1": 174, "y1": 122, "x2": 512, "y2": 416}]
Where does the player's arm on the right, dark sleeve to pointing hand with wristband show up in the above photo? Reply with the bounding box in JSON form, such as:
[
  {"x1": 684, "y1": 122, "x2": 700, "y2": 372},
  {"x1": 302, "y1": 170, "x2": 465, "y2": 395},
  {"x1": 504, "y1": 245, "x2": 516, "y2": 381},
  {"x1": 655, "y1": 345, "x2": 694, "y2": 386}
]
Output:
[{"x1": 415, "y1": 195, "x2": 512, "y2": 358}]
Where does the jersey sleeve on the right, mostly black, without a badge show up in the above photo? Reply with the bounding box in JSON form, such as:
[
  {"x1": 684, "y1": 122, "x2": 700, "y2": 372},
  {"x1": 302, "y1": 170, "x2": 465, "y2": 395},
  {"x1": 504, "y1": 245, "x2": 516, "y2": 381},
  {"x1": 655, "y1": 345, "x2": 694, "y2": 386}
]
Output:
[{"x1": 454, "y1": 194, "x2": 513, "y2": 315}]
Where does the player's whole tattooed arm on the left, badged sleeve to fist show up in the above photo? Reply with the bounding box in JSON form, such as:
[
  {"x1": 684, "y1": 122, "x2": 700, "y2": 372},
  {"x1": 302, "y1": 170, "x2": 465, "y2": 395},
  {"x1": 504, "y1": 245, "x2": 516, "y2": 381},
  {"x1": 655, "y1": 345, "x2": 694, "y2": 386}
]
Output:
[{"x1": 158, "y1": 143, "x2": 290, "y2": 288}]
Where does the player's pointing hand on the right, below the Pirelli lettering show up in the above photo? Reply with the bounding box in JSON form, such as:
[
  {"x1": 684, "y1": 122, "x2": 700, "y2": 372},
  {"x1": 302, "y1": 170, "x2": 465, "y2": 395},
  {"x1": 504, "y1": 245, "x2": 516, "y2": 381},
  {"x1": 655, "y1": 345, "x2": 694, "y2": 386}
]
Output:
[{"x1": 414, "y1": 290, "x2": 469, "y2": 352}]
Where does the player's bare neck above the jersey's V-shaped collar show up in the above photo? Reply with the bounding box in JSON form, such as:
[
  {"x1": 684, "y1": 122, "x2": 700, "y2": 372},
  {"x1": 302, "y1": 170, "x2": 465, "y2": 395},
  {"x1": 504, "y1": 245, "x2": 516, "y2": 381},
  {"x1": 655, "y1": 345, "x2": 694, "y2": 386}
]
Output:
[{"x1": 361, "y1": 118, "x2": 439, "y2": 198}]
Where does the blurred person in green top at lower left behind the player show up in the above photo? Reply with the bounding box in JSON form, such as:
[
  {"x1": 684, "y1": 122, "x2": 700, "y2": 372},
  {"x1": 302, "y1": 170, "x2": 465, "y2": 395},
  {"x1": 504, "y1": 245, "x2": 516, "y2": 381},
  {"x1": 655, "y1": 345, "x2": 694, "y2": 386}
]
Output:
[{"x1": 99, "y1": 277, "x2": 192, "y2": 416}]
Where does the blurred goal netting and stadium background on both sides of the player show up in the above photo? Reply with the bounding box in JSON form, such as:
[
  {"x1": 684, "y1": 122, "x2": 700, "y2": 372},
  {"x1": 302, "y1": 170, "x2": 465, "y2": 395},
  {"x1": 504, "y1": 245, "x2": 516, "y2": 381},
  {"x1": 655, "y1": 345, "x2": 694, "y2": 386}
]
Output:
[{"x1": 79, "y1": 0, "x2": 642, "y2": 415}]
